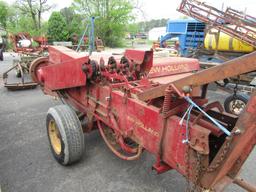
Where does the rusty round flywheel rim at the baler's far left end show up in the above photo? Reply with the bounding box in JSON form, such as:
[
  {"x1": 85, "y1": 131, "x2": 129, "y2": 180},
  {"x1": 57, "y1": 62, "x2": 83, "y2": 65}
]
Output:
[{"x1": 29, "y1": 57, "x2": 49, "y2": 84}]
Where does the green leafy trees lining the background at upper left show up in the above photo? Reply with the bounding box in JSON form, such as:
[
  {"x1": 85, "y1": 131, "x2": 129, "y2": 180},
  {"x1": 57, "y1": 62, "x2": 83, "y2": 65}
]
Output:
[{"x1": 0, "y1": 0, "x2": 170, "y2": 47}]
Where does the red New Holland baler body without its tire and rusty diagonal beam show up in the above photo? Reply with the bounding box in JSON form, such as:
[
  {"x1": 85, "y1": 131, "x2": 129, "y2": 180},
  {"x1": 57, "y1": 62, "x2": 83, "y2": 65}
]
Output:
[{"x1": 32, "y1": 47, "x2": 256, "y2": 189}]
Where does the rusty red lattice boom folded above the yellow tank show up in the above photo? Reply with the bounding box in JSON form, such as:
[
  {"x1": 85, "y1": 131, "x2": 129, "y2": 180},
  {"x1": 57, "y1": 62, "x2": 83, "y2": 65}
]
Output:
[{"x1": 178, "y1": 0, "x2": 256, "y2": 47}]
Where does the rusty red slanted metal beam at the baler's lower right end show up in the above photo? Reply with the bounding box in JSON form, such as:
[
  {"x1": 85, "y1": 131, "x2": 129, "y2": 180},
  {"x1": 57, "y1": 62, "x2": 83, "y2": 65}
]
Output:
[{"x1": 202, "y1": 94, "x2": 256, "y2": 190}]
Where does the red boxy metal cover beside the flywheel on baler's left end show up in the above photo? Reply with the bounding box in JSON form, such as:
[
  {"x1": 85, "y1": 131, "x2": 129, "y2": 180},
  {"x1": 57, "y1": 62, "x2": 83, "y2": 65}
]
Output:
[{"x1": 38, "y1": 47, "x2": 89, "y2": 91}]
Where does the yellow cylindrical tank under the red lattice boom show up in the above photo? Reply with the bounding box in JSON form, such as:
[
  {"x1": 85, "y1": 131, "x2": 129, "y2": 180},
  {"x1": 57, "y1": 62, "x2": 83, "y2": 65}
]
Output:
[{"x1": 204, "y1": 30, "x2": 255, "y2": 53}]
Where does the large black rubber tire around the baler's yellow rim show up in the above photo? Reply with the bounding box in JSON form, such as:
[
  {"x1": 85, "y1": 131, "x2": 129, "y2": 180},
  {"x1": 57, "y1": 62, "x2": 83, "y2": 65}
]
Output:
[{"x1": 46, "y1": 105, "x2": 84, "y2": 165}]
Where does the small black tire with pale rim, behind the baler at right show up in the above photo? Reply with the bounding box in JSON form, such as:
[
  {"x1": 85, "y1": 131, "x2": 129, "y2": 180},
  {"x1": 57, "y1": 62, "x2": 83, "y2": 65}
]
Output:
[{"x1": 224, "y1": 93, "x2": 250, "y2": 116}]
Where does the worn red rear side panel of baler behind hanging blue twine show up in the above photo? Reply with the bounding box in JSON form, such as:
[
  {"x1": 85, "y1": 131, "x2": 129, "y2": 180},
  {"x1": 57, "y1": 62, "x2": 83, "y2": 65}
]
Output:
[{"x1": 163, "y1": 116, "x2": 210, "y2": 175}]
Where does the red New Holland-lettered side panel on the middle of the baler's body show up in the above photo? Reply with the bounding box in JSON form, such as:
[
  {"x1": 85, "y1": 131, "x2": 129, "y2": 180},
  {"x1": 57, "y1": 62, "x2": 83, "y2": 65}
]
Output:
[{"x1": 110, "y1": 91, "x2": 162, "y2": 154}]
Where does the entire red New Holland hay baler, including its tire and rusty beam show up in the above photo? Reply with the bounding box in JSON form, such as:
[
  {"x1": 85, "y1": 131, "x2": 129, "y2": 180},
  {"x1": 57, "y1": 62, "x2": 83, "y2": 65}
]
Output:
[{"x1": 30, "y1": 46, "x2": 256, "y2": 191}]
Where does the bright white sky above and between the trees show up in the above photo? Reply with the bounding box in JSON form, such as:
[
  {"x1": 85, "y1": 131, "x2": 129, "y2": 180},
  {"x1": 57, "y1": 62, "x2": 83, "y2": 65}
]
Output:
[{"x1": 4, "y1": 0, "x2": 256, "y2": 21}]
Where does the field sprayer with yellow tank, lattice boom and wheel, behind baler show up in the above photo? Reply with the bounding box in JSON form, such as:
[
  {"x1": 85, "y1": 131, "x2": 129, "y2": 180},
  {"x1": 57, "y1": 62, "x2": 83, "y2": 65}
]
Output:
[{"x1": 178, "y1": 0, "x2": 256, "y2": 115}]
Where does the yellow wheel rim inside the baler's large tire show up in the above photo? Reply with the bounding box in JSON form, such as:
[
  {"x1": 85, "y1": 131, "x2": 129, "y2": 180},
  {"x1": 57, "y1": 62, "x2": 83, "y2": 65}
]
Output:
[{"x1": 48, "y1": 120, "x2": 61, "y2": 155}]
